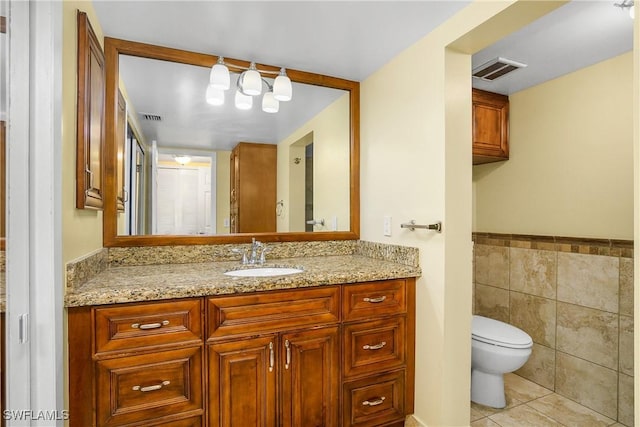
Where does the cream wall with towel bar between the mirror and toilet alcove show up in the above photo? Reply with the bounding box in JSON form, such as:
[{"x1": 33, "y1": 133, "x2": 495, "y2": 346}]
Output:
[{"x1": 361, "y1": 2, "x2": 561, "y2": 426}]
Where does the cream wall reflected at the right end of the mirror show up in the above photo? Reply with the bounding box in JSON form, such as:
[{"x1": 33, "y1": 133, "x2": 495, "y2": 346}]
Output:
[{"x1": 277, "y1": 95, "x2": 350, "y2": 231}]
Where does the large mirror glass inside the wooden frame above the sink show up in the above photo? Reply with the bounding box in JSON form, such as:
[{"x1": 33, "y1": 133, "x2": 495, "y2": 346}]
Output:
[{"x1": 105, "y1": 39, "x2": 357, "y2": 247}]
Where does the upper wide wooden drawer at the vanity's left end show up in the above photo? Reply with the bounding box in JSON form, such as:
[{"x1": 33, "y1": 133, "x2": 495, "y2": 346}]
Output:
[{"x1": 94, "y1": 299, "x2": 202, "y2": 353}]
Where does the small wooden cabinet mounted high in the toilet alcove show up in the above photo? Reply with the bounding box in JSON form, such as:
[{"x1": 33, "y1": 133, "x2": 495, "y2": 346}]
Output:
[{"x1": 472, "y1": 89, "x2": 509, "y2": 165}]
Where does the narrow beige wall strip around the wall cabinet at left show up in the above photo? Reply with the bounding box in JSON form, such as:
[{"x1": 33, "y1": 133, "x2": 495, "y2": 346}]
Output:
[{"x1": 62, "y1": 0, "x2": 103, "y2": 263}]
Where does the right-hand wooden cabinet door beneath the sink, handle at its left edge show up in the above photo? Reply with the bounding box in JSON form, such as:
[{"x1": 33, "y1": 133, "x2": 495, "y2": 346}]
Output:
[{"x1": 280, "y1": 326, "x2": 340, "y2": 427}]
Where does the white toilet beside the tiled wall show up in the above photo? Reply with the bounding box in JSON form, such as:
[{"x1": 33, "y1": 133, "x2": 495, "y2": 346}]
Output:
[{"x1": 471, "y1": 316, "x2": 533, "y2": 408}]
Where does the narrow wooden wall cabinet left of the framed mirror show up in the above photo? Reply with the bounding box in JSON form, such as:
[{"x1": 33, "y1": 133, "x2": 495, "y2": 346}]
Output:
[{"x1": 76, "y1": 11, "x2": 105, "y2": 209}]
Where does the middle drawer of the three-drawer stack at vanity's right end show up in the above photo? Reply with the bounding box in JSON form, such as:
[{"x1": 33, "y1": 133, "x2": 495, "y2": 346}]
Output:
[{"x1": 343, "y1": 316, "x2": 406, "y2": 376}]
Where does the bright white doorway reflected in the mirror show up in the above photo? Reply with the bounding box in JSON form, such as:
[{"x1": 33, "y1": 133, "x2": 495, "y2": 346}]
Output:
[{"x1": 153, "y1": 153, "x2": 216, "y2": 235}]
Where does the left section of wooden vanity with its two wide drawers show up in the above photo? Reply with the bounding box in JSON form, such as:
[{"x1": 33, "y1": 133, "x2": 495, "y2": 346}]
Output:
[{"x1": 68, "y1": 299, "x2": 205, "y2": 427}]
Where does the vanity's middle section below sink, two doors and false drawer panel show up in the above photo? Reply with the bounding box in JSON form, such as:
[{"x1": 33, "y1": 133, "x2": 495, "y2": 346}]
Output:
[{"x1": 207, "y1": 286, "x2": 340, "y2": 427}]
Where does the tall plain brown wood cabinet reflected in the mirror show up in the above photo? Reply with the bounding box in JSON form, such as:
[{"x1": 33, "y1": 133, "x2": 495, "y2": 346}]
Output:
[{"x1": 229, "y1": 142, "x2": 277, "y2": 233}]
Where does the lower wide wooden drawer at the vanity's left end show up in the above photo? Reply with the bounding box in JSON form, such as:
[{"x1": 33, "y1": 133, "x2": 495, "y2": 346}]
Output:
[{"x1": 96, "y1": 347, "x2": 204, "y2": 427}]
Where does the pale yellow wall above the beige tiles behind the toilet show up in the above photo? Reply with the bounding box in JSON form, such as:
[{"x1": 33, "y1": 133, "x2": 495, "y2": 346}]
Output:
[{"x1": 473, "y1": 52, "x2": 633, "y2": 239}]
